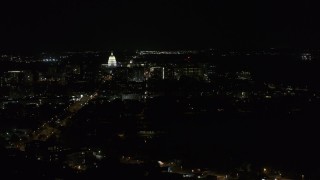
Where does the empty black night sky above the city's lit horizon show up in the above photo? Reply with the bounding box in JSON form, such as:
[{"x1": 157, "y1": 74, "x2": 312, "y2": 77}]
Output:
[{"x1": 0, "y1": 0, "x2": 320, "y2": 52}]
